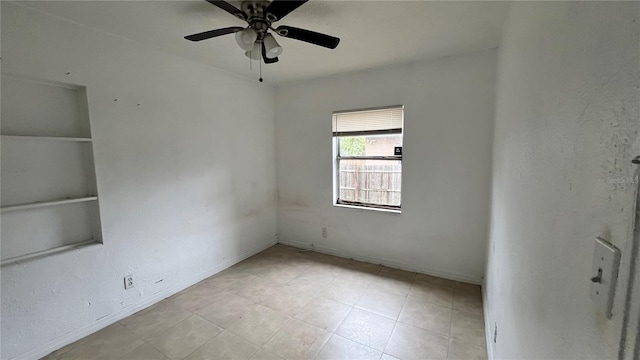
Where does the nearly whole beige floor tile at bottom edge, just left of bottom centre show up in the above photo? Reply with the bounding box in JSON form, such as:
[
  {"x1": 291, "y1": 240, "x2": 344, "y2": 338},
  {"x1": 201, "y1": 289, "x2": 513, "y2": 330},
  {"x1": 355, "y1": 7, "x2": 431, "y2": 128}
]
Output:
[{"x1": 265, "y1": 319, "x2": 331, "y2": 360}]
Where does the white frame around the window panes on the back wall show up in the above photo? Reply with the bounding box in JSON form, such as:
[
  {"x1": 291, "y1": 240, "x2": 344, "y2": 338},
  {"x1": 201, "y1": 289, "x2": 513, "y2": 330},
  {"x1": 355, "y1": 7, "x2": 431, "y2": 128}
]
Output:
[{"x1": 331, "y1": 105, "x2": 404, "y2": 213}]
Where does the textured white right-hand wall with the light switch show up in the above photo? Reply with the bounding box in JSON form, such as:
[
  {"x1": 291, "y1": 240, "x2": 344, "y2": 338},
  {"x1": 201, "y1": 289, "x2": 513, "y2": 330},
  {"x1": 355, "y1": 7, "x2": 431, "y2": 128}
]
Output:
[{"x1": 485, "y1": 2, "x2": 640, "y2": 359}]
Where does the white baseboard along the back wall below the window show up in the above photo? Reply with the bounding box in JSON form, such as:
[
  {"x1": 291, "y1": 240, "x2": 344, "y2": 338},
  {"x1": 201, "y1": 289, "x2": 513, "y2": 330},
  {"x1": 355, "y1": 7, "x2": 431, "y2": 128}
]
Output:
[{"x1": 278, "y1": 239, "x2": 482, "y2": 285}]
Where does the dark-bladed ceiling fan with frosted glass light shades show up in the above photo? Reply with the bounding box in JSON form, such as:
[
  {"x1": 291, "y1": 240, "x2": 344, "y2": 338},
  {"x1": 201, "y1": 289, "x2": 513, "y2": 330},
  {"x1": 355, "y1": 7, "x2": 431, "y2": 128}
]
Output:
[{"x1": 185, "y1": 0, "x2": 340, "y2": 67}]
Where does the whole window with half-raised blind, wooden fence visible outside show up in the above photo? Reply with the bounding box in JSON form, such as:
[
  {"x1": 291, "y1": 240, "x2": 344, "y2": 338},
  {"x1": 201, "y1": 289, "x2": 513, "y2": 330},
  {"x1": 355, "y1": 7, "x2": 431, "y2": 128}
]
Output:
[{"x1": 333, "y1": 105, "x2": 404, "y2": 210}]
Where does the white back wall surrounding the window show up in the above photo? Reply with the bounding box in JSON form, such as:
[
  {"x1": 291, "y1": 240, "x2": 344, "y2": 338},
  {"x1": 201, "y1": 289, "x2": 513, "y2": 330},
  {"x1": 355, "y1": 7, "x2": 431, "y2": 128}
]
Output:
[{"x1": 276, "y1": 50, "x2": 496, "y2": 283}]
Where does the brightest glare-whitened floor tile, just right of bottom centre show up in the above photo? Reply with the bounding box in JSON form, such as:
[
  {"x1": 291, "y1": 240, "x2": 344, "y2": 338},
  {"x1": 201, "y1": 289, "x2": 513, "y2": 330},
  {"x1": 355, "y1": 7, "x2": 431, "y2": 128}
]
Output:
[{"x1": 335, "y1": 308, "x2": 396, "y2": 351}]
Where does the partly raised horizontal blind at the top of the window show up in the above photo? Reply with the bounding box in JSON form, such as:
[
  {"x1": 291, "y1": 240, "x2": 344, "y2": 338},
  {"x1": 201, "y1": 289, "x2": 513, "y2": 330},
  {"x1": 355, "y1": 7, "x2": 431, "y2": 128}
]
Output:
[{"x1": 333, "y1": 106, "x2": 404, "y2": 136}]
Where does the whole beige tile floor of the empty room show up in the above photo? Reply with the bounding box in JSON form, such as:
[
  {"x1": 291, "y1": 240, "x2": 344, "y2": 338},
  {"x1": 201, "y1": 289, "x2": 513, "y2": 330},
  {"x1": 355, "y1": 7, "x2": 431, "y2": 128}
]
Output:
[{"x1": 45, "y1": 245, "x2": 487, "y2": 360}]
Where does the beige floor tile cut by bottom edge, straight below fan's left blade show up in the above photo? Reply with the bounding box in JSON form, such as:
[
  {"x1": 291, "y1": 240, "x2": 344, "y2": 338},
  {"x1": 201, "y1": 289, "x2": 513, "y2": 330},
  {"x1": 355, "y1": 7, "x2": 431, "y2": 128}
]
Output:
[{"x1": 187, "y1": 330, "x2": 260, "y2": 360}]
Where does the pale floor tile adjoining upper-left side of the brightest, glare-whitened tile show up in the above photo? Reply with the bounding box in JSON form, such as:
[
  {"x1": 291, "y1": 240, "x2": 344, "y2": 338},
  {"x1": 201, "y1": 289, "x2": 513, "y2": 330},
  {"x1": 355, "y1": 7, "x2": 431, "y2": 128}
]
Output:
[{"x1": 296, "y1": 297, "x2": 351, "y2": 331}]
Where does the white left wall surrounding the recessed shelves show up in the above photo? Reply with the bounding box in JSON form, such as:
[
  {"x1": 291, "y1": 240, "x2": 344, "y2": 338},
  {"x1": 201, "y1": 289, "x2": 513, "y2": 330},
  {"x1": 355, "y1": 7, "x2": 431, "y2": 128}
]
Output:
[{"x1": 0, "y1": 2, "x2": 277, "y2": 359}]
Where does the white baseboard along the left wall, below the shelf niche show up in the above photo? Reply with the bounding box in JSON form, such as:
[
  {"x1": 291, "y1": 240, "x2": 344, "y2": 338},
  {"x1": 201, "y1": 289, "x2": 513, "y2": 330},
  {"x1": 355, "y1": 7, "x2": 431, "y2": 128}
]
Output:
[{"x1": 12, "y1": 241, "x2": 276, "y2": 360}]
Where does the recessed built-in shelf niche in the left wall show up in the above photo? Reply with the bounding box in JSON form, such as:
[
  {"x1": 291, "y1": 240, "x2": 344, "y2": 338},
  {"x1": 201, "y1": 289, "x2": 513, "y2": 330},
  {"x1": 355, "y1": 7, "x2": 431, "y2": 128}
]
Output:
[{"x1": 0, "y1": 73, "x2": 102, "y2": 266}]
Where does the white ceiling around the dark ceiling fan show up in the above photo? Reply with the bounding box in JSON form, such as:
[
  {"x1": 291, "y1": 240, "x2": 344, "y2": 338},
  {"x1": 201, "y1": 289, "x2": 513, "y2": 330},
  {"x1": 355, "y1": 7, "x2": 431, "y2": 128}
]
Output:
[{"x1": 16, "y1": 0, "x2": 509, "y2": 84}]
